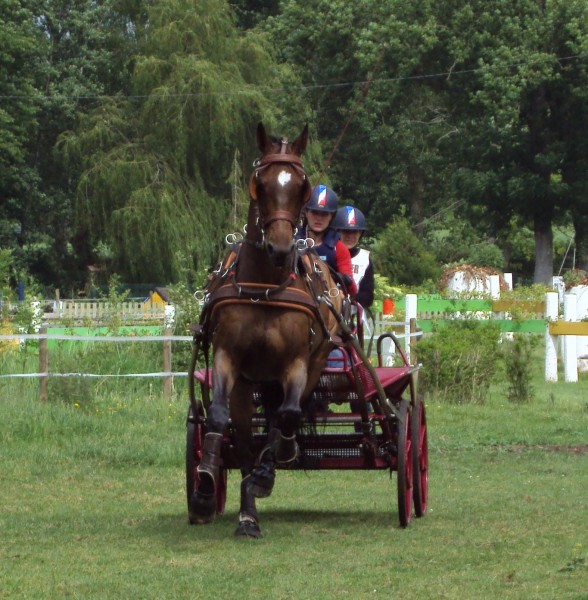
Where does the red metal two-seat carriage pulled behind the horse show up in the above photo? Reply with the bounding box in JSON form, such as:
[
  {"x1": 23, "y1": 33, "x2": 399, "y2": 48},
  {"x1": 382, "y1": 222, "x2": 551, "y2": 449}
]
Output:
[{"x1": 186, "y1": 333, "x2": 428, "y2": 527}]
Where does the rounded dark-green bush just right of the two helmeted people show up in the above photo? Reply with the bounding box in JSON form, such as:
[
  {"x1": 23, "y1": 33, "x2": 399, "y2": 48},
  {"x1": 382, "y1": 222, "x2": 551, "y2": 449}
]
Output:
[{"x1": 373, "y1": 217, "x2": 439, "y2": 285}]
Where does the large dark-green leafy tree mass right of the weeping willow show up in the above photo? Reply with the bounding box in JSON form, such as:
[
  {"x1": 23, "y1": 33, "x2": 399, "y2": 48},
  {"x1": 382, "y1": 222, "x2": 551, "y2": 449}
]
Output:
[{"x1": 267, "y1": 0, "x2": 588, "y2": 282}]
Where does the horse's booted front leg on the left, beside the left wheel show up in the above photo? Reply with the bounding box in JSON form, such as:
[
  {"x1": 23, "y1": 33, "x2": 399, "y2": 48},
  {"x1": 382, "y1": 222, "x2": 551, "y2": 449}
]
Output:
[{"x1": 190, "y1": 352, "x2": 234, "y2": 524}]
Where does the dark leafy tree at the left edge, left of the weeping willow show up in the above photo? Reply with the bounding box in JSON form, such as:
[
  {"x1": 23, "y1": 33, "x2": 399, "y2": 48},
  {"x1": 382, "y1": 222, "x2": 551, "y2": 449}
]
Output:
[{"x1": 0, "y1": 0, "x2": 146, "y2": 286}]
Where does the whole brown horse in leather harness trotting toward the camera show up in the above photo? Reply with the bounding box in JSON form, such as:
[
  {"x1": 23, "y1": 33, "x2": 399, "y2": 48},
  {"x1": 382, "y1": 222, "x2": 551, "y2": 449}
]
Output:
[{"x1": 189, "y1": 123, "x2": 342, "y2": 537}]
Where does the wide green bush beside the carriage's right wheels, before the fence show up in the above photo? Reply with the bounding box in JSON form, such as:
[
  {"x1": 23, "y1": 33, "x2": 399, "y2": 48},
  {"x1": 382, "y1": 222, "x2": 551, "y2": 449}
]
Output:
[{"x1": 416, "y1": 319, "x2": 500, "y2": 404}]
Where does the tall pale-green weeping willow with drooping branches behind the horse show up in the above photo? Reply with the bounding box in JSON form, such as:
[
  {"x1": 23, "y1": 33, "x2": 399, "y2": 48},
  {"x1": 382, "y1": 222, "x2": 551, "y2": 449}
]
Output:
[{"x1": 61, "y1": 0, "x2": 306, "y2": 282}]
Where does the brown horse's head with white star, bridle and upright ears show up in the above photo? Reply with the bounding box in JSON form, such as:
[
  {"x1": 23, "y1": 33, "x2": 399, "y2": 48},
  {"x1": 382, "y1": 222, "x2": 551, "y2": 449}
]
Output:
[{"x1": 247, "y1": 123, "x2": 311, "y2": 266}]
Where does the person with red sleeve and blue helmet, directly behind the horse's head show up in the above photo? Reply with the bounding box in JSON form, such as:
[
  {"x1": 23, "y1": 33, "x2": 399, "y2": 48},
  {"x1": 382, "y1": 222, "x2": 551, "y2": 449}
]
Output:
[{"x1": 297, "y1": 185, "x2": 357, "y2": 297}]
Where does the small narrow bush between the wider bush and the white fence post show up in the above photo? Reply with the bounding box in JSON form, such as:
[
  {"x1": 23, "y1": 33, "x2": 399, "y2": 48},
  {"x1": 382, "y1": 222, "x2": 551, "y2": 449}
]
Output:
[{"x1": 501, "y1": 334, "x2": 538, "y2": 404}]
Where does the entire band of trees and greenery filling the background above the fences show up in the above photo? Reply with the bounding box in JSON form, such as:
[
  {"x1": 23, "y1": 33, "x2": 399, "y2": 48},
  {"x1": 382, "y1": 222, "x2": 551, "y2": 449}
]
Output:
[{"x1": 0, "y1": 0, "x2": 588, "y2": 295}]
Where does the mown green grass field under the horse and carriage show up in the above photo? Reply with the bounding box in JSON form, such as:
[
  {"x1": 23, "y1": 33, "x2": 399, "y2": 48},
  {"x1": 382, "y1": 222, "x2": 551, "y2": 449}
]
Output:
[{"x1": 0, "y1": 354, "x2": 588, "y2": 600}]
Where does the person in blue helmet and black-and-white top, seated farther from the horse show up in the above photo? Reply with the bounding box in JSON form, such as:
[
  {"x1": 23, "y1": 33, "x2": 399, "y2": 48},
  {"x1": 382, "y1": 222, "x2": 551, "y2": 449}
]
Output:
[{"x1": 333, "y1": 206, "x2": 375, "y2": 309}]
